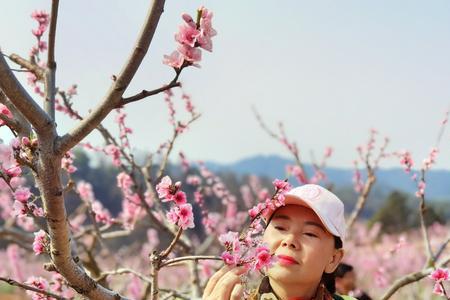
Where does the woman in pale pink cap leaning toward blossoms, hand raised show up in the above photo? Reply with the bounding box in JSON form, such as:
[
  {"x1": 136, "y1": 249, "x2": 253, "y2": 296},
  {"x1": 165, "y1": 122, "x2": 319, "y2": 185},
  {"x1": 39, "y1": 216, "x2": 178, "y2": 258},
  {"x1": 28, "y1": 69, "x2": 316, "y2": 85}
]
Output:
[{"x1": 203, "y1": 184, "x2": 353, "y2": 300}]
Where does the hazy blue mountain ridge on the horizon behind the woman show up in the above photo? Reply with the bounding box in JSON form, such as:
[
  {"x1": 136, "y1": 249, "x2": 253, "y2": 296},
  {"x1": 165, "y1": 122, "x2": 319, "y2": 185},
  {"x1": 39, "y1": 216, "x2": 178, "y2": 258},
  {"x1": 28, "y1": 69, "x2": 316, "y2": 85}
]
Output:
[{"x1": 206, "y1": 155, "x2": 450, "y2": 201}]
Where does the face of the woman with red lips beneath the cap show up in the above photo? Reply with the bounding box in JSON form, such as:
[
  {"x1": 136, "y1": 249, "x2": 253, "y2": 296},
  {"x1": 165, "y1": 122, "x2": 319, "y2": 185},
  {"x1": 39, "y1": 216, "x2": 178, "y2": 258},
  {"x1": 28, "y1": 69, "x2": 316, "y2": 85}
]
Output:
[{"x1": 263, "y1": 205, "x2": 343, "y2": 286}]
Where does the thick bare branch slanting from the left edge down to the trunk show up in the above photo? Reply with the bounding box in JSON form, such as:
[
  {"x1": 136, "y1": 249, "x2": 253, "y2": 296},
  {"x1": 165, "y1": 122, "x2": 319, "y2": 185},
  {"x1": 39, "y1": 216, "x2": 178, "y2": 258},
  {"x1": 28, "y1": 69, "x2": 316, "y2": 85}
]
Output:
[{"x1": 0, "y1": 49, "x2": 53, "y2": 132}]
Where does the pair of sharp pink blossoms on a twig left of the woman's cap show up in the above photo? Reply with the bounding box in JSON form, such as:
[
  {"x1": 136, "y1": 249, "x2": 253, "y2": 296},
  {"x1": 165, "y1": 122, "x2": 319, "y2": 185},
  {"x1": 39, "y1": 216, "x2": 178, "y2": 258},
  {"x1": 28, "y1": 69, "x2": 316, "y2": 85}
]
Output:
[{"x1": 156, "y1": 176, "x2": 195, "y2": 230}]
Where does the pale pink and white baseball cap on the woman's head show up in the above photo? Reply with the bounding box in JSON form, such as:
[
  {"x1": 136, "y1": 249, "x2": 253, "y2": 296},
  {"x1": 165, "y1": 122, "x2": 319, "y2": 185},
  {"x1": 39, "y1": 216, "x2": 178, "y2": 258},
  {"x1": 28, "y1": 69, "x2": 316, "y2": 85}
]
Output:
[{"x1": 266, "y1": 184, "x2": 346, "y2": 240}]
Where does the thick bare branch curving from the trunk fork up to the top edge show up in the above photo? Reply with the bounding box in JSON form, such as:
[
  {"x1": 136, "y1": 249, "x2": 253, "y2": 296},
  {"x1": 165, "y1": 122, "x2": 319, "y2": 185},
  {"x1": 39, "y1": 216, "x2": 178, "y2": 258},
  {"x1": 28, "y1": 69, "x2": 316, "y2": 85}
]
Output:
[{"x1": 56, "y1": 0, "x2": 165, "y2": 153}]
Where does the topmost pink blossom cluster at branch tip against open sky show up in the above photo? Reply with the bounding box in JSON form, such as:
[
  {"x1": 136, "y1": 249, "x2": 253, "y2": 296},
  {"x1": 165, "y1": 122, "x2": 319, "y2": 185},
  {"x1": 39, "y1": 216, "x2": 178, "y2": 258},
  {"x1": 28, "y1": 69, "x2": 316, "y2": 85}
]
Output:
[{"x1": 163, "y1": 7, "x2": 217, "y2": 69}]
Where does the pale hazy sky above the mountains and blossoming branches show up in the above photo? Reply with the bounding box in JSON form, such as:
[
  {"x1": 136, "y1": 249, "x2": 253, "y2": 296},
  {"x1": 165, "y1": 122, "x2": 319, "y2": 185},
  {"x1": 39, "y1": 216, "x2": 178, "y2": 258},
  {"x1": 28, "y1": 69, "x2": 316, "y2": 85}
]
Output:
[{"x1": 0, "y1": 0, "x2": 450, "y2": 169}]
